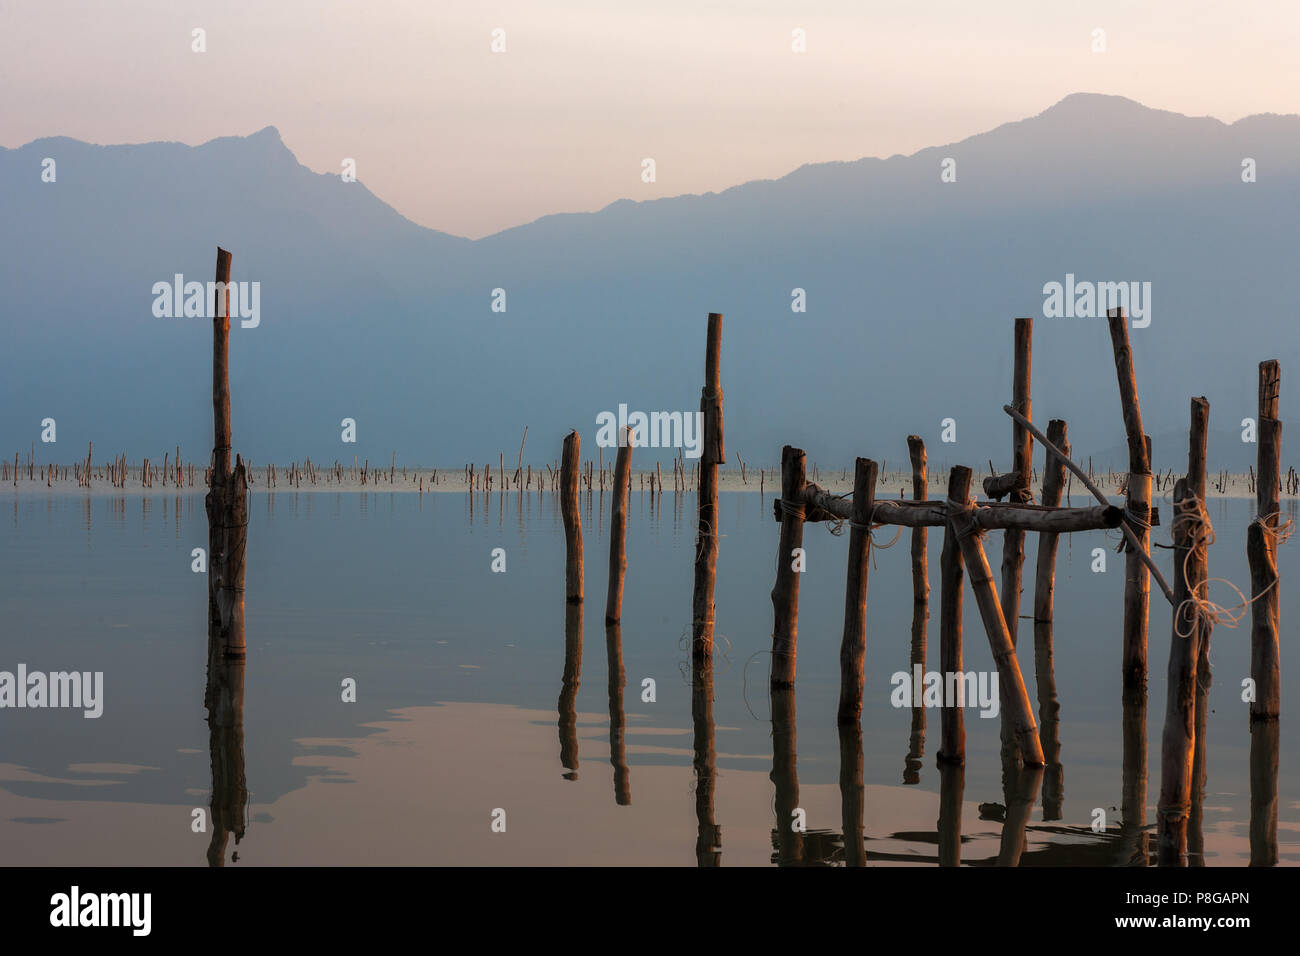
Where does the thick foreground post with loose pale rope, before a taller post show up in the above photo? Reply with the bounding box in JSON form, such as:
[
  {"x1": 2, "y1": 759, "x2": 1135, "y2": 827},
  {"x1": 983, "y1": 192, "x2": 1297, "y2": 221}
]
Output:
[{"x1": 1157, "y1": 479, "x2": 1205, "y2": 866}]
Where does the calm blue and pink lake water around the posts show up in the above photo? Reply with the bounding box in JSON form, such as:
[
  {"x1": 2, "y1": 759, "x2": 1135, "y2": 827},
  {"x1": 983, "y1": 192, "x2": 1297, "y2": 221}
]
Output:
[{"x1": 0, "y1": 490, "x2": 1300, "y2": 866}]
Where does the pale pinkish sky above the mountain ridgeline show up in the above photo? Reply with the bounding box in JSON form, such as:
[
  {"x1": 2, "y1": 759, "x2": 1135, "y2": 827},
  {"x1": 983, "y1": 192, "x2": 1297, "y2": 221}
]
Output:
[{"x1": 0, "y1": 0, "x2": 1300, "y2": 238}]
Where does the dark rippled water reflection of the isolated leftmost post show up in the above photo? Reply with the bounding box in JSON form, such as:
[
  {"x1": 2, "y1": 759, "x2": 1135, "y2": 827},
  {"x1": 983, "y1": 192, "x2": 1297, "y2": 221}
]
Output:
[{"x1": 204, "y1": 633, "x2": 248, "y2": 866}]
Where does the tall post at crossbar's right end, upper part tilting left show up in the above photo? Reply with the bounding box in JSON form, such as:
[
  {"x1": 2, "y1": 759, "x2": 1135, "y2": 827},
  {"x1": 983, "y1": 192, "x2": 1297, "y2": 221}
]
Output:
[{"x1": 1106, "y1": 308, "x2": 1152, "y2": 693}]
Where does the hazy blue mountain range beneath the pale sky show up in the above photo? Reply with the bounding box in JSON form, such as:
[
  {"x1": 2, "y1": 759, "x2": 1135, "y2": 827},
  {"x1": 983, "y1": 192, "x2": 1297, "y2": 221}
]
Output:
[{"x1": 0, "y1": 94, "x2": 1300, "y2": 470}]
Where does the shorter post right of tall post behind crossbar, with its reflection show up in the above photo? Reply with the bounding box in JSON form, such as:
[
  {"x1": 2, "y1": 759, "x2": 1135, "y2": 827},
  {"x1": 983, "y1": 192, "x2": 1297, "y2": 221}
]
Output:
[{"x1": 1034, "y1": 419, "x2": 1070, "y2": 821}]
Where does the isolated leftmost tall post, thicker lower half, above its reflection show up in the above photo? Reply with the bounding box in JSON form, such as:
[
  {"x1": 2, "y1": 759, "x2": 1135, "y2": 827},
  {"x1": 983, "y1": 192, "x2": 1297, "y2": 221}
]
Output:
[{"x1": 204, "y1": 247, "x2": 248, "y2": 657}]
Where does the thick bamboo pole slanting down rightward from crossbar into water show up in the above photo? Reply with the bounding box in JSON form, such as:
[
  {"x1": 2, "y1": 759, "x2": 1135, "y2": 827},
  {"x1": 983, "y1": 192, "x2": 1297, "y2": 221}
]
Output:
[{"x1": 948, "y1": 466, "x2": 1043, "y2": 766}]
